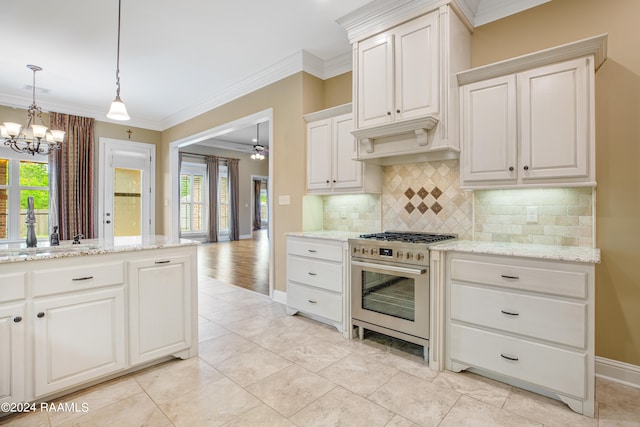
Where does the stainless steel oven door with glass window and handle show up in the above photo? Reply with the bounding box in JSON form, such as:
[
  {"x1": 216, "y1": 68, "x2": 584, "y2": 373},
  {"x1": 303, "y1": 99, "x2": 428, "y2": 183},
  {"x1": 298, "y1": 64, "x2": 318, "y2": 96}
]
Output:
[{"x1": 351, "y1": 260, "x2": 429, "y2": 339}]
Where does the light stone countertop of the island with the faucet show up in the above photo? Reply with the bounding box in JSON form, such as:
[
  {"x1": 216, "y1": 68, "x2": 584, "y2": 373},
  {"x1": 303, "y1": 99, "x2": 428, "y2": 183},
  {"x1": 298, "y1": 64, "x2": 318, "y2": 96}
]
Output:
[{"x1": 0, "y1": 235, "x2": 199, "y2": 264}]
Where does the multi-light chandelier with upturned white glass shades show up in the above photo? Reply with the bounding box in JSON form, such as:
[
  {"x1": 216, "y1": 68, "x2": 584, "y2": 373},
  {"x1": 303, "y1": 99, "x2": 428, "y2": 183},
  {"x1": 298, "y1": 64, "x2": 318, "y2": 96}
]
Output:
[{"x1": 0, "y1": 65, "x2": 64, "y2": 156}]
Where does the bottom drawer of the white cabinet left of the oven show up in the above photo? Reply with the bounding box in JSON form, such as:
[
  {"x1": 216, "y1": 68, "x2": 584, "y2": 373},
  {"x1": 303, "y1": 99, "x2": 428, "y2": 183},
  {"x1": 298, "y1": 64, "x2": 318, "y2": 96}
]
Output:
[{"x1": 287, "y1": 282, "x2": 342, "y2": 322}]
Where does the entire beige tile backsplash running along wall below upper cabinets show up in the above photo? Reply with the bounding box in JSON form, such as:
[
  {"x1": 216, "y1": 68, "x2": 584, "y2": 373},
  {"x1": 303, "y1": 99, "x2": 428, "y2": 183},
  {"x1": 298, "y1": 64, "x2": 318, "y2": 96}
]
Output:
[{"x1": 304, "y1": 160, "x2": 595, "y2": 247}]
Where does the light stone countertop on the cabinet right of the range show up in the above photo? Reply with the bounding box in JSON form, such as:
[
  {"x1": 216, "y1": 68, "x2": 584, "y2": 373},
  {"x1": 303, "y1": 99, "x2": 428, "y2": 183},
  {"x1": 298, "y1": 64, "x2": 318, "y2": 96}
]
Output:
[{"x1": 430, "y1": 240, "x2": 600, "y2": 264}]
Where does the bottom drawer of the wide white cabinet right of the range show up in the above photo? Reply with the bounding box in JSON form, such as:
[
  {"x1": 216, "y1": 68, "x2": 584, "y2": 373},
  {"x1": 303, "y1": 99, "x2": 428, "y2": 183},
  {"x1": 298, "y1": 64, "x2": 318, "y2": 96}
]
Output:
[{"x1": 449, "y1": 324, "x2": 587, "y2": 399}]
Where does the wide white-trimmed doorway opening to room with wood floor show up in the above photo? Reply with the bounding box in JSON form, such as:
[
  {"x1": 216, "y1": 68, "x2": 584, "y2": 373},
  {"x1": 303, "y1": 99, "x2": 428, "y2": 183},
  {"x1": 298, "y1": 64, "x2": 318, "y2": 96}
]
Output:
[{"x1": 169, "y1": 109, "x2": 273, "y2": 296}]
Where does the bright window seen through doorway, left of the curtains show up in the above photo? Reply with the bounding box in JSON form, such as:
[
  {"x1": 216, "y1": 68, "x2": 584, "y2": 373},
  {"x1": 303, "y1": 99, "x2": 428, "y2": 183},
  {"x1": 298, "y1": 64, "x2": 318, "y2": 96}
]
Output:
[{"x1": 180, "y1": 162, "x2": 207, "y2": 234}]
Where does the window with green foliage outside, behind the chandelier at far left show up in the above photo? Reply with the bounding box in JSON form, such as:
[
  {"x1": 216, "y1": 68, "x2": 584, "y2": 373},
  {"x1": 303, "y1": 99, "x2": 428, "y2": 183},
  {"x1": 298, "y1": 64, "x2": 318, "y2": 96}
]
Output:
[{"x1": 0, "y1": 150, "x2": 49, "y2": 241}]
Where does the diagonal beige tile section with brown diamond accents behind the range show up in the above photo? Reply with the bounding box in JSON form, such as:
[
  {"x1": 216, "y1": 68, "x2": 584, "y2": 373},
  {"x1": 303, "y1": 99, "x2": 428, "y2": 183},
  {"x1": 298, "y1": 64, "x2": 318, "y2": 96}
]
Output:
[{"x1": 382, "y1": 160, "x2": 473, "y2": 239}]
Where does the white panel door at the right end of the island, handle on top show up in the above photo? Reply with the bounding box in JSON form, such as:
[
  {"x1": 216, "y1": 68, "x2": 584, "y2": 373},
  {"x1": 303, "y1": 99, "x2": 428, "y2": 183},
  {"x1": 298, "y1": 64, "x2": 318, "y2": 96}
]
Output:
[{"x1": 129, "y1": 256, "x2": 192, "y2": 365}]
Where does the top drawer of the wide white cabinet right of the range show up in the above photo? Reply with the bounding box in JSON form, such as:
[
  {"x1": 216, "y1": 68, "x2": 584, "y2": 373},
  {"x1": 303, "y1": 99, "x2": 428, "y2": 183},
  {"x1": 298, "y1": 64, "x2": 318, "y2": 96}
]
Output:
[{"x1": 451, "y1": 259, "x2": 587, "y2": 298}]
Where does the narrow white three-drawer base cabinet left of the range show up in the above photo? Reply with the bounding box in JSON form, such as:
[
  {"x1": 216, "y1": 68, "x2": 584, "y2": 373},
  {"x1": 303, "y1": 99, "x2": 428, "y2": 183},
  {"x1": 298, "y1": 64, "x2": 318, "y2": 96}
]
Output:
[{"x1": 287, "y1": 236, "x2": 349, "y2": 334}]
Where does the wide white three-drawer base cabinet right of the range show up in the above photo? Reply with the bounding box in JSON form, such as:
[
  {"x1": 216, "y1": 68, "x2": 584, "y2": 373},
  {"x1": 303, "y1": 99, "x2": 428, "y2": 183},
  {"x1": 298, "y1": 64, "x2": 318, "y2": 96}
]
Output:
[{"x1": 446, "y1": 252, "x2": 595, "y2": 417}]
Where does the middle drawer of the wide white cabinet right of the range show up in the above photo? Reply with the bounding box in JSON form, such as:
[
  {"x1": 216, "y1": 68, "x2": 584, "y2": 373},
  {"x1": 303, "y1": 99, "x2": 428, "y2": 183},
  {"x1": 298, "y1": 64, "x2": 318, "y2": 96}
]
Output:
[{"x1": 451, "y1": 283, "x2": 587, "y2": 348}]
